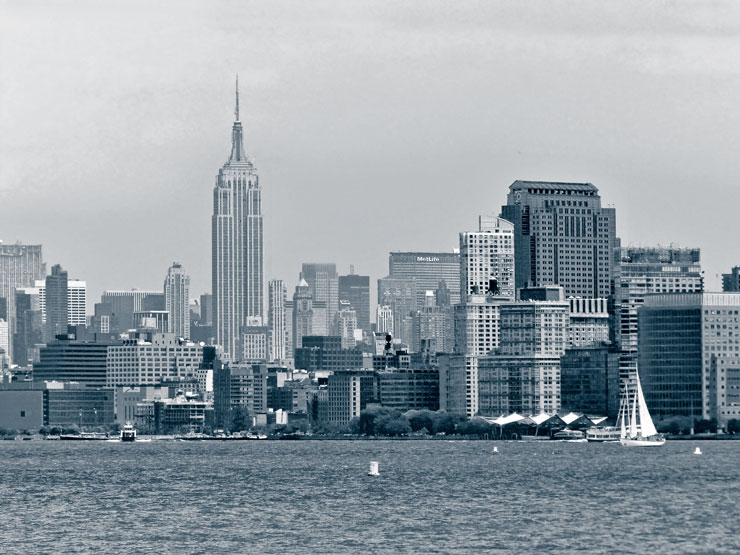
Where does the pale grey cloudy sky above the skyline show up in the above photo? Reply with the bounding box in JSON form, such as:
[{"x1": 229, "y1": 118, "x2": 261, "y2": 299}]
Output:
[{"x1": 0, "y1": 0, "x2": 740, "y2": 310}]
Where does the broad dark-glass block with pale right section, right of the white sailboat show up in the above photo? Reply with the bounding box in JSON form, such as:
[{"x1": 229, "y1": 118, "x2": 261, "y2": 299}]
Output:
[{"x1": 638, "y1": 293, "x2": 740, "y2": 426}]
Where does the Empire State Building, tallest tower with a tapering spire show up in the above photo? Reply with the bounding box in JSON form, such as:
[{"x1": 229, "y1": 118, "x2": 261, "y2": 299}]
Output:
[{"x1": 211, "y1": 78, "x2": 264, "y2": 360}]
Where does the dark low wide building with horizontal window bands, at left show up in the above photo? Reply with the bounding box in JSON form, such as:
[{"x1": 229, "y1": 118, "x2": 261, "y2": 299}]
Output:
[{"x1": 33, "y1": 336, "x2": 115, "y2": 387}]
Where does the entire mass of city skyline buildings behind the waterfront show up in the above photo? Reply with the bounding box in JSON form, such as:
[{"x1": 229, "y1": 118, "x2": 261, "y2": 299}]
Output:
[{"x1": 0, "y1": 86, "x2": 740, "y2": 433}]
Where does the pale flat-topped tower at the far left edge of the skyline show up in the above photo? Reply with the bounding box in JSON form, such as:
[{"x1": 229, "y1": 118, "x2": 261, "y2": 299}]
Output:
[{"x1": 0, "y1": 241, "x2": 46, "y2": 355}]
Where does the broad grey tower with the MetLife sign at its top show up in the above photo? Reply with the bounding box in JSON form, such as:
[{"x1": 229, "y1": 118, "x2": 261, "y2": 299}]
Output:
[{"x1": 390, "y1": 252, "x2": 460, "y2": 311}]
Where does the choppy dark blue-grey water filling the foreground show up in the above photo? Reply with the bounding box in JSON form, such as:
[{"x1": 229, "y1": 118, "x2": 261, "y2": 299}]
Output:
[{"x1": 0, "y1": 441, "x2": 740, "y2": 553}]
